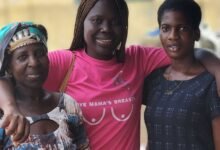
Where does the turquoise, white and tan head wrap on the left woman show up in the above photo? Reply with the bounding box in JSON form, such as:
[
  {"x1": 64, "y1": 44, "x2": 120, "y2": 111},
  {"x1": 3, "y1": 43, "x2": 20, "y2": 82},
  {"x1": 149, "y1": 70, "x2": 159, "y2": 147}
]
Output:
[{"x1": 0, "y1": 22, "x2": 47, "y2": 74}]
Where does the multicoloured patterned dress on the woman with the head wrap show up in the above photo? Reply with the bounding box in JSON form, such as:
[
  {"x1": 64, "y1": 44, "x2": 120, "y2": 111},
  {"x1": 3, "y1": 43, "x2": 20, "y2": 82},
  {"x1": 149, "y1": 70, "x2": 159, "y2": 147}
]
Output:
[{"x1": 4, "y1": 94, "x2": 88, "y2": 150}]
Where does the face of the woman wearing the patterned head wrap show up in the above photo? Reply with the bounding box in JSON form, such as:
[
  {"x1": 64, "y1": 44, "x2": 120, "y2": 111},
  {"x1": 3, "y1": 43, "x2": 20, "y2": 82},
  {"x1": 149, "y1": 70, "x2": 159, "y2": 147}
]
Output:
[{"x1": 8, "y1": 44, "x2": 49, "y2": 88}]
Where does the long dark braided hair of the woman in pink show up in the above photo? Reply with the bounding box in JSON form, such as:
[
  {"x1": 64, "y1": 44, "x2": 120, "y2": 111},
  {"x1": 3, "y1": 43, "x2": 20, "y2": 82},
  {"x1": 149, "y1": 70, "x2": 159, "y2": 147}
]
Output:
[{"x1": 70, "y1": 0, "x2": 128, "y2": 61}]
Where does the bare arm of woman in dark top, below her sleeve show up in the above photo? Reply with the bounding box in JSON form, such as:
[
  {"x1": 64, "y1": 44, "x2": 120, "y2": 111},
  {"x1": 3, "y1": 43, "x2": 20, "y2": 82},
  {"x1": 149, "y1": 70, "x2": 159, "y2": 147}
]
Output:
[{"x1": 212, "y1": 117, "x2": 220, "y2": 150}]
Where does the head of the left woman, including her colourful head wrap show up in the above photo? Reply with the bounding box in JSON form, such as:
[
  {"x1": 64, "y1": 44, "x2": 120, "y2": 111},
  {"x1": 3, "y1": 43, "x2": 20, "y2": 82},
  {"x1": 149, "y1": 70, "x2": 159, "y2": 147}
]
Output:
[{"x1": 0, "y1": 22, "x2": 49, "y2": 85}]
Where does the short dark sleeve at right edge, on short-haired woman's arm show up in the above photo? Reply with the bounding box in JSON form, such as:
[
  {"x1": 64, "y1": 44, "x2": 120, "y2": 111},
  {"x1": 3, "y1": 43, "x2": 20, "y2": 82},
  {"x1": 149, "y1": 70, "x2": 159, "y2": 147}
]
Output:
[{"x1": 207, "y1": 81, "x2": 220, "y2": 119}]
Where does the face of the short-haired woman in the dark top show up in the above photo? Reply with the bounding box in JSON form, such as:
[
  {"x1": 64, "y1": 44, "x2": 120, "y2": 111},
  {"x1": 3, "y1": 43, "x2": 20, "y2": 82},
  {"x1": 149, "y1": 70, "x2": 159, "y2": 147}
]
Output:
[{"x1": 160, "y1": 10, "x2": 200, "y2": 59}]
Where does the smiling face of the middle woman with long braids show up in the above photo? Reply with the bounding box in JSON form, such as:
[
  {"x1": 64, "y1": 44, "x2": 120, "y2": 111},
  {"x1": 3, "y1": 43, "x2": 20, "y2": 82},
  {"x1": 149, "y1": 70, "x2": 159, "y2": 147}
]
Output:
[{"x1": 84, "y1": 0, "x2": 122, "y2": 60}]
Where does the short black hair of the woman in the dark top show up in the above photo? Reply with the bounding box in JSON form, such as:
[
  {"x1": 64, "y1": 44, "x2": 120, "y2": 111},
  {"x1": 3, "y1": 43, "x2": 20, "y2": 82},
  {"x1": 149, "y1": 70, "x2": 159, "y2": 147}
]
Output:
[{"x1": 157, "y1": 0, "x2": 202, "y2": 29}]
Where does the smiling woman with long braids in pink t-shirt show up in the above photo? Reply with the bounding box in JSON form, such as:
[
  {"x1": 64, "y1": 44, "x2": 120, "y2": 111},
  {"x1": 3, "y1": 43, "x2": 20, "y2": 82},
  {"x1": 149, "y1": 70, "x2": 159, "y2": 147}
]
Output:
[{"x1": 0, "y1": 0, "x2": 220, "y2": 150}]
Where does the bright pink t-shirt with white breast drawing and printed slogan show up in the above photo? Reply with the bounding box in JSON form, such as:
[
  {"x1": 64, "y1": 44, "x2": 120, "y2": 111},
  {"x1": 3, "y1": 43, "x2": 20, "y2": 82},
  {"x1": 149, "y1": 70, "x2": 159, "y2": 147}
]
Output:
[{"x1": 45, "y1": 46, "x2": 170, "y2": 150}]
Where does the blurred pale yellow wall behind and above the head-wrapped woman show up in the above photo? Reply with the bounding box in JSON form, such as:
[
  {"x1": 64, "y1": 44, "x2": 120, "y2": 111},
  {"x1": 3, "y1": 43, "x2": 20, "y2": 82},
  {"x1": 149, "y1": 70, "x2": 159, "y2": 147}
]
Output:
[{"x1": 0, "y1": 0, "x2": 76, "y2": 49}]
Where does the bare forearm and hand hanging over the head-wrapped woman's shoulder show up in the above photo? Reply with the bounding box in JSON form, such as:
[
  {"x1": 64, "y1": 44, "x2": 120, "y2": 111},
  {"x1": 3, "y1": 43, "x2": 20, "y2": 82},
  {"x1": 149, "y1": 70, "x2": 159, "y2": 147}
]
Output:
[{"x1": 0, "y1": 78, "x2": 30, "y2": 144}]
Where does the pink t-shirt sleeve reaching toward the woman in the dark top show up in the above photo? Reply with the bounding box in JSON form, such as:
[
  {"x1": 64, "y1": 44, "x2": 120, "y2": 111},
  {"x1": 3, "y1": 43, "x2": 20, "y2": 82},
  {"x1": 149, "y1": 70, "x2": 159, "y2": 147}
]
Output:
[{"x1": 127, "y1": 45, "x2": 170, "y2": 77}]
